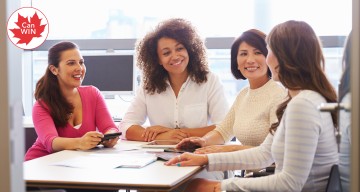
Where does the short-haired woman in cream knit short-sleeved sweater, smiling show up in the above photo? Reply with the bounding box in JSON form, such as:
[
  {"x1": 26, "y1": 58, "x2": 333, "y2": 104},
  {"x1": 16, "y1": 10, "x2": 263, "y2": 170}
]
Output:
[{"x1": 177, "y1": 29, "x2": 286, "y2": 154}]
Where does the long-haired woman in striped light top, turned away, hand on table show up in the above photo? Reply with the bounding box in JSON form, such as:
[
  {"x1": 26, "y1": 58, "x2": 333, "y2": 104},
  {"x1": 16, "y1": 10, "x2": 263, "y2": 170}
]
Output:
[{"x1": 166, "y1": 21, "x2": 338, "y2": 192}]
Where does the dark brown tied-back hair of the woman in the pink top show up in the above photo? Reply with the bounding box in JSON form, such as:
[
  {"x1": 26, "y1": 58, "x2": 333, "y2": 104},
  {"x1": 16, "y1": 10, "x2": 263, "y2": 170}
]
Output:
[{"x1": 34, "y1": 41, "x2": 79, "y2": 127}]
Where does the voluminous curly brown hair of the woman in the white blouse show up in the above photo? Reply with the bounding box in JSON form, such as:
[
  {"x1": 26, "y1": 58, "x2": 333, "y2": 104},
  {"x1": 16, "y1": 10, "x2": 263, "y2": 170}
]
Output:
[{"x1": 136, "y1": 18, "x2": 209, "y2": 94}]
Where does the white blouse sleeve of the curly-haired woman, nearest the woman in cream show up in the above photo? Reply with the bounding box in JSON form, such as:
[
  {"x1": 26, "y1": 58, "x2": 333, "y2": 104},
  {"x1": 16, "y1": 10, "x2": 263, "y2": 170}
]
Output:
[{"x1": 208, "y1": 74, "x2": 229, "y2": 124}]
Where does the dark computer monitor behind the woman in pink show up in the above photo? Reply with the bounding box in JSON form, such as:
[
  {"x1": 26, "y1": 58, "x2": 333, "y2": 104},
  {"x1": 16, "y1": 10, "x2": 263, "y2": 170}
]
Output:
[{"x1": 82, "y1": 53, "x2": 135, "y2": 98}]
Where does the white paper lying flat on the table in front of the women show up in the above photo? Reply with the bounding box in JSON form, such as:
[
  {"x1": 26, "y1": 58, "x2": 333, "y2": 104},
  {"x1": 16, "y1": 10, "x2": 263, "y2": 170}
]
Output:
[{"x1": 52, "y1": 153, "x2": 157, "y2": 169}]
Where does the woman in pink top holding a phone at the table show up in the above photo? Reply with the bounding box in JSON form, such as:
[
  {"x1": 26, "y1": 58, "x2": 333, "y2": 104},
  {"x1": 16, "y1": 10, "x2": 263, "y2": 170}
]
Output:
[{"x1": 25, "y1": 41, "x2": 118, "y2": 160}]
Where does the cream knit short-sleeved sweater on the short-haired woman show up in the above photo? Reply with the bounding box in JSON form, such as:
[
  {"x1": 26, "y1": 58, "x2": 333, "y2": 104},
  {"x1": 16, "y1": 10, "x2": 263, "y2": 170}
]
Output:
[{"x1": 215, "y1": 79, "x2": 287, "y2": 146}]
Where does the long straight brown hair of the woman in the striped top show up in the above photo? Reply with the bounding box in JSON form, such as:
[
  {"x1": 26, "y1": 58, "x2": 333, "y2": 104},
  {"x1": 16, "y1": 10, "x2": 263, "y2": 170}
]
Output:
[{"x1": 266, "y1": 20, "x2": 337, "y2": 134}]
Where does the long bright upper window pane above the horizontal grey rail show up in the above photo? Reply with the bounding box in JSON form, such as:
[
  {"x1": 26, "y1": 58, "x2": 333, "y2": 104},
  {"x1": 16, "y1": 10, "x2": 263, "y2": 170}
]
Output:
[{"x1": 32, "y1": 0, "x2": 352, "y2": 39}]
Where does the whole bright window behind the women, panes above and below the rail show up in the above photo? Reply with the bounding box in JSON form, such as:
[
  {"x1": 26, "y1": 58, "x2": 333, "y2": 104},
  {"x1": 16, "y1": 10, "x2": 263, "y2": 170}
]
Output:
[{"x1": 23, "y1": 0, "x2": 352, "y2": 115}]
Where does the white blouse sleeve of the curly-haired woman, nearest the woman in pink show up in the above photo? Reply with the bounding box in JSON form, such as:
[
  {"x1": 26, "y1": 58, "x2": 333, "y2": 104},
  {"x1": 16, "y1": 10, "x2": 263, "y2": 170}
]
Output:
[{"x1": 119, "y1": 87, "x2": 147, "y2": 139}]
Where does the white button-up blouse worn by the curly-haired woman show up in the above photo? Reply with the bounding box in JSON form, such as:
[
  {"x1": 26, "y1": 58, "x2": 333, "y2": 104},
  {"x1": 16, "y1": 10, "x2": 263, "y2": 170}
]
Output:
[{"x1": 119, "y1": 73, "x2": 229, "y2": 139}]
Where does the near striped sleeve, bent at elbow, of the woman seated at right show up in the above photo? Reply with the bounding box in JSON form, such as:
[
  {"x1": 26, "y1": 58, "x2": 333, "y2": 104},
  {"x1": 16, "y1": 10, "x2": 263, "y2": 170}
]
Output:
[{"x1": 221, "y1": 99, "x2": 321, "y2": 191}]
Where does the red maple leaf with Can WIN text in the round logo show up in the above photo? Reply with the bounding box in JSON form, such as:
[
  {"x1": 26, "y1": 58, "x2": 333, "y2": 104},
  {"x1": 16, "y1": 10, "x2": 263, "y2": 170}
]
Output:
[{"x1": 10, "y1": 12, "x2": 46, "y2": 45}]
